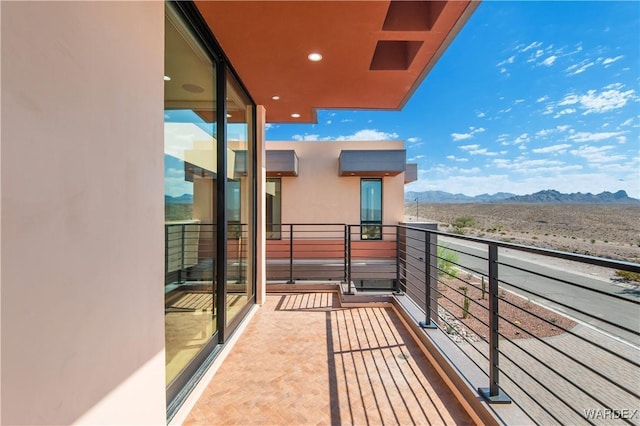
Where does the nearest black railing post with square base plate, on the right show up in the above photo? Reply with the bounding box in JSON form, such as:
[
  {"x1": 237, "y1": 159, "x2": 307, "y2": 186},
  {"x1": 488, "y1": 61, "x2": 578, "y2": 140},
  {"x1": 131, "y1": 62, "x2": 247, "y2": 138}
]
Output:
[{"x1": 478, "y1": 244, "x2": 511, "y2": 404}]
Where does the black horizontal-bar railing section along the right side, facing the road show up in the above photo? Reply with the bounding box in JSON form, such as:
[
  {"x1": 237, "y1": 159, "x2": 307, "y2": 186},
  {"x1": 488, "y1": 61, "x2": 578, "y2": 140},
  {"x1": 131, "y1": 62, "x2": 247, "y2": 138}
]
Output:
[{"x1": 398, "y1": 227, "x2": 640, "y2": 424}]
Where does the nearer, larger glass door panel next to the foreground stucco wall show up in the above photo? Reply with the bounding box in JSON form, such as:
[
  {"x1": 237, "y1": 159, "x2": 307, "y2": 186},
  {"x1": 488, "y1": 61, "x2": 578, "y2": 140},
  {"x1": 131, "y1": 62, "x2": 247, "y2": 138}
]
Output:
[{"x1": 164, "y1": 7, "x2": 217, "y2": 385}]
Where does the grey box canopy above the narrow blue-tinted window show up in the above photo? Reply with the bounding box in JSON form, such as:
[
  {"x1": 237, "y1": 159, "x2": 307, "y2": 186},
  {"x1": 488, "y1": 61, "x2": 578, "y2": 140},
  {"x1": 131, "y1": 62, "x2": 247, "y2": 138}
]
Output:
[{"x1": 339, "y1": 149, "x2": 406, "y2": 177}]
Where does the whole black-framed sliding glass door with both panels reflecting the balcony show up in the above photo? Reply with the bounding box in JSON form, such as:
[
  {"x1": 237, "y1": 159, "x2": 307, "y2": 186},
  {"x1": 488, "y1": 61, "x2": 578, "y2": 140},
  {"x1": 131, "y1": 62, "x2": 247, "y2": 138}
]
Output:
[{"x1": 164, "y1": 3, "x2": 256, "y2": 410}]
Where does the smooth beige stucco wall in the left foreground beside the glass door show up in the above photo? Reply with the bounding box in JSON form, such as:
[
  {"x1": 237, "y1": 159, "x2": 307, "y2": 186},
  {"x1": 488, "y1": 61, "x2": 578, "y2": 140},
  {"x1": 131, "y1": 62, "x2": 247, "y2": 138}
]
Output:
[{"x1": 0, "y1": 1, "x2": 165, "y2": 424}]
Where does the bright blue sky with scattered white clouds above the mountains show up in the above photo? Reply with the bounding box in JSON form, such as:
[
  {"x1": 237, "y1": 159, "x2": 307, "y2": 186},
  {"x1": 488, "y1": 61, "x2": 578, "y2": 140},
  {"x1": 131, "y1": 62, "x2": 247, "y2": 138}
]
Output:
[{"x1": 267, "y1": 1, "x2": 640, "y2": 198}]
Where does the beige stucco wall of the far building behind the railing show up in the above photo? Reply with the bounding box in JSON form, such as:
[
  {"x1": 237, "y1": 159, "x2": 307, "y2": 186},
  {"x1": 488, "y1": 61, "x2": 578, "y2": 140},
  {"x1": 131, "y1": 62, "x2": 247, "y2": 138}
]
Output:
[{"x1": 266, "y1": 141, "x2": 404, "y2": 225}]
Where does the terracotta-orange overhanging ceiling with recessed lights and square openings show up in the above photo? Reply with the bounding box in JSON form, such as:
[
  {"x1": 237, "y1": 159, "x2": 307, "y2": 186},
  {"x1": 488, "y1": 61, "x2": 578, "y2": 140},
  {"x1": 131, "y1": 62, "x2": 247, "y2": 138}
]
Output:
[{"x1": 196, "y1": 0, "x2": 478, "y2": 123}]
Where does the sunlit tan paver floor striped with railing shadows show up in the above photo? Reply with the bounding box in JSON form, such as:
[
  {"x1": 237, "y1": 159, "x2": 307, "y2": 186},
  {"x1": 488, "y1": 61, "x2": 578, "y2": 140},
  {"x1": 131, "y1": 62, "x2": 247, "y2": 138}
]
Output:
[{"x1": 185, "y1": 293, "x2": 473, "y2": 425}]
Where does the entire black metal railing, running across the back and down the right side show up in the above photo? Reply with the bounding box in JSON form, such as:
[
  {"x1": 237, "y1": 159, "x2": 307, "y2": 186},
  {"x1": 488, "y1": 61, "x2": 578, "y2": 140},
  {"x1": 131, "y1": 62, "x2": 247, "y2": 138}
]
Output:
[{"x1": 267, "y1": 224, "x2": 640, "y2": 424}]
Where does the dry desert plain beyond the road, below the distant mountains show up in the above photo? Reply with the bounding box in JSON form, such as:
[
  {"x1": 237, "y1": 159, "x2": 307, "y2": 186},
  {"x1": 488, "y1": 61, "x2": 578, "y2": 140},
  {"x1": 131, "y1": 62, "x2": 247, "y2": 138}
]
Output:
[{"x1": 405, "y1": 203, "x2": 640, "y2": 262}]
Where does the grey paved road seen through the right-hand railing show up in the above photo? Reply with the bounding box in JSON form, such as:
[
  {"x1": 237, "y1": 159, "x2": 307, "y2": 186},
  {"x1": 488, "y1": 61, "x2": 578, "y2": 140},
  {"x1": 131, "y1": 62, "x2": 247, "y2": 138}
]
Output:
[{"x1": 438, "y1": 237, "x2": 640, "y2": 346}]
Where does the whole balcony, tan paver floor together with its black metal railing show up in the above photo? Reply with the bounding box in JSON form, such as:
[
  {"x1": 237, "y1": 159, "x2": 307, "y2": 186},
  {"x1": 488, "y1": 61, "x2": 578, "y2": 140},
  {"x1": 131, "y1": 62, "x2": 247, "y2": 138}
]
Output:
[{"x1": 170, "y1": 224, "x2": 640, "y2": 424}]
